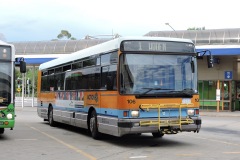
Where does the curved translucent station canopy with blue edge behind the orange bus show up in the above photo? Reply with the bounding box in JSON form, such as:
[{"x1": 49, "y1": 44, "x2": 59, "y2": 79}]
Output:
[{"x1": 7, "y1": 28, "x2": 240, "y2": 65}]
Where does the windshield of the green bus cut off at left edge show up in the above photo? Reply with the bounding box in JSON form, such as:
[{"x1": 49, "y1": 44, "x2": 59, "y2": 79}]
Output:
[{"x1": 0, "y1": 62, "x2": 12, "y2": 106}]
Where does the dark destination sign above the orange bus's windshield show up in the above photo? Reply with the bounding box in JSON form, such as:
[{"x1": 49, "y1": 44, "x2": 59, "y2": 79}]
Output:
[{"x1": 121, "y1": 40, "x2": 195, "y2": 53}]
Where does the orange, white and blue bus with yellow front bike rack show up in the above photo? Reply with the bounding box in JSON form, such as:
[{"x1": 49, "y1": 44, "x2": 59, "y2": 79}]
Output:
[{"x1": 37, "y1": 37, "x2": 204, "y2": 139}]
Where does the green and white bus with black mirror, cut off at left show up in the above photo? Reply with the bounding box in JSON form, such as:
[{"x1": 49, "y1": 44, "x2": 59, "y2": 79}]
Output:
[{"x1": 0, "y1": 40, "x2": 26, "y2": 134}]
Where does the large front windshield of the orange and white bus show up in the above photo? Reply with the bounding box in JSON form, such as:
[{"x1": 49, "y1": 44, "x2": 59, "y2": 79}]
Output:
[{"x1": 120, "y1": 53, "x2": 197, "y2": 95}]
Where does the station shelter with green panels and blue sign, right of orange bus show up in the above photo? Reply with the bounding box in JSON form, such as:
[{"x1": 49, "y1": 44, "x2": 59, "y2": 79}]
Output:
[{"x1": 197, "y1": 45, "x2": 240, "y2": 111}]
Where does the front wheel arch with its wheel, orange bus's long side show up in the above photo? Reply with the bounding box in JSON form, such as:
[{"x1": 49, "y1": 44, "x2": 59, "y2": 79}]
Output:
[{"x1": 88, "y1": 107, "x2": 100, "y2": 139}]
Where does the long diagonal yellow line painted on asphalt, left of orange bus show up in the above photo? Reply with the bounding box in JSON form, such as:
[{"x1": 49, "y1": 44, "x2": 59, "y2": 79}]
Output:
[{"x1": 28, "y1": 126, "x2": 97, "y2": 160}]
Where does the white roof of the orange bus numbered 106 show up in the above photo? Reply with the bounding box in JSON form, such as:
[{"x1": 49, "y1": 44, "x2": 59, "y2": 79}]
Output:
[{"x1": 39, "y1": 36, "x2": 193, "y2": 70}]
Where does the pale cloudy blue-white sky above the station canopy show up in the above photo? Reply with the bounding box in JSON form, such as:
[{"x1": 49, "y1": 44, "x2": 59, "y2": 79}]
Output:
[{"x1": 0, "y1": 0, "x2": 240, "y2": 42}]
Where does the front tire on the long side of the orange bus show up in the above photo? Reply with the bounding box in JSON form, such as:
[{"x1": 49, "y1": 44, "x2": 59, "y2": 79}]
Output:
[{"x1": 89, "y1": 110, "x2": 100, "y2": 139}]
